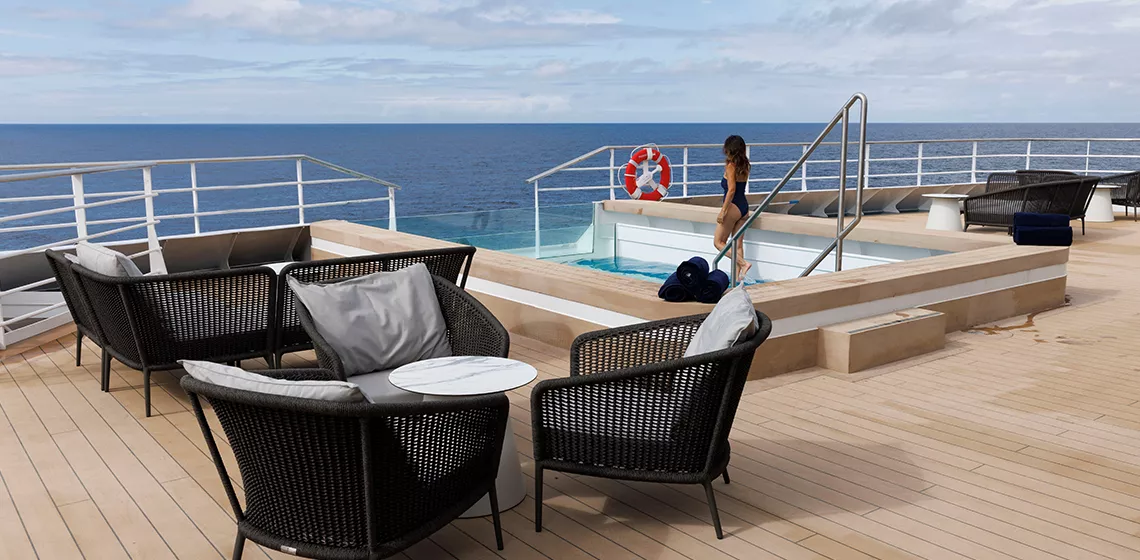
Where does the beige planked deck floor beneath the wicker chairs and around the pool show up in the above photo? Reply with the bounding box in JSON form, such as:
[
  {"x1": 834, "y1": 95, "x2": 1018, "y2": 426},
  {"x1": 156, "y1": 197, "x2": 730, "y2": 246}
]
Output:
[{"x1": 0, "y1": 214, "x2": 1140, "y2": 560}]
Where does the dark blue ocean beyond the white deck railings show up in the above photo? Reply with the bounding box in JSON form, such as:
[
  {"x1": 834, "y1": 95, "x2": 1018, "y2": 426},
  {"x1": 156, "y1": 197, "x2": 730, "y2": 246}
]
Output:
[{"x1": 0, "y1": 122, "x2": 1140, "y2": 249}]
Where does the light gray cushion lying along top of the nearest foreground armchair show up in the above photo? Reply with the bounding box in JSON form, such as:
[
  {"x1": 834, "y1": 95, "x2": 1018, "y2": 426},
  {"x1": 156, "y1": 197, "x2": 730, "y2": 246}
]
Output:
[{"x1": 179, "y1": 359, "x2": 365, "y2": 403}]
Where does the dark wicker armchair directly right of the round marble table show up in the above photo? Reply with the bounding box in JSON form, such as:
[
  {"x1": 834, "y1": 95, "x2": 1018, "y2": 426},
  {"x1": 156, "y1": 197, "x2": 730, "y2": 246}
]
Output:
[{"x1": 530, "y1": 311, "x2": 772, "y2": 538}]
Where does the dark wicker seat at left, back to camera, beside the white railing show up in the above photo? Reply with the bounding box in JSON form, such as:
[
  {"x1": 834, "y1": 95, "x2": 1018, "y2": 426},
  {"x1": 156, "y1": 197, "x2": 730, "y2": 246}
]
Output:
[{"x1": 72, "y1": 265, "x2": 277, "y2": 416}]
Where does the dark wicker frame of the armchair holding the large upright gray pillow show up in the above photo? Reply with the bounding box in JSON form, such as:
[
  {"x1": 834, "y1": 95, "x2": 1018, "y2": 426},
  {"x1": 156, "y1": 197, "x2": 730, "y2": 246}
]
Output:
[{"x1": 291, "y1": 276, "x2": 511, "y2": 381}]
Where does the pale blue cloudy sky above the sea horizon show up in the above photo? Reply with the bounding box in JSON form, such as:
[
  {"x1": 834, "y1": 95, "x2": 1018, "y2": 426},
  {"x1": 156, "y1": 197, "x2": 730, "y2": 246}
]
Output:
[{"x1": 0, "y1": 0, "x2": 1140, "y2": 123}]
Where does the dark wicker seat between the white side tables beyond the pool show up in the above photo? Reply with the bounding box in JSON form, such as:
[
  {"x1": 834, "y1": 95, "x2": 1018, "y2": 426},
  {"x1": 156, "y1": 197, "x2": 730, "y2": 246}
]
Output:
[{"x1": 964, "y1": 176, "x2": 1100, "y2": 232}]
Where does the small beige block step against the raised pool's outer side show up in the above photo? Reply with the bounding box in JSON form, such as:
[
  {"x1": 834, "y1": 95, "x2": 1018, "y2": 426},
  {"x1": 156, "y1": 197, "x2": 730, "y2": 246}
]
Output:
[{"x1": 819, "y1": 309, "x2": 946, "y2": 373}]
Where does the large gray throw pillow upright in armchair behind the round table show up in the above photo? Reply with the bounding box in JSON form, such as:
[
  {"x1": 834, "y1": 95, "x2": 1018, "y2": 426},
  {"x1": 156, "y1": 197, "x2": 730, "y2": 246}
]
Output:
[{"x1": 288, "y1": 262, "x2": 451, "y2": 375}]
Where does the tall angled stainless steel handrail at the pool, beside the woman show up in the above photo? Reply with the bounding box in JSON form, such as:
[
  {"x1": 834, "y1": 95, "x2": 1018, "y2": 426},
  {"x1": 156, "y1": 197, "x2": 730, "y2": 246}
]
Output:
[{"x1": 713, "y1": 94, "x2": 866, "y2": 285}]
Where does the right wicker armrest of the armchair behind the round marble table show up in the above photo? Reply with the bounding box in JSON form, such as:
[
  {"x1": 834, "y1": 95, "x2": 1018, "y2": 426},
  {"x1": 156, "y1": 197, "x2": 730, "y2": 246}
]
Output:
[{"x1": 432, "y1": 276, "x2": 511, "y2": 358}]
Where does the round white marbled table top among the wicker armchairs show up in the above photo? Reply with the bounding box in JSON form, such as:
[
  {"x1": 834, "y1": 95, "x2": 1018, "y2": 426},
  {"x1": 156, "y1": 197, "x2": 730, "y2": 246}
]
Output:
[{"x1": 388, "y1": 356, "x2": 538, "y2": 397}]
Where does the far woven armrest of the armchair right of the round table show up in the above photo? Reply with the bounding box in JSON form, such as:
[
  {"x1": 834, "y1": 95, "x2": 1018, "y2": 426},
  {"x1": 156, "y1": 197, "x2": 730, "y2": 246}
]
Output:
[{"x1": 570, "y1": 315, "x2": 708, "y2": 375}]
